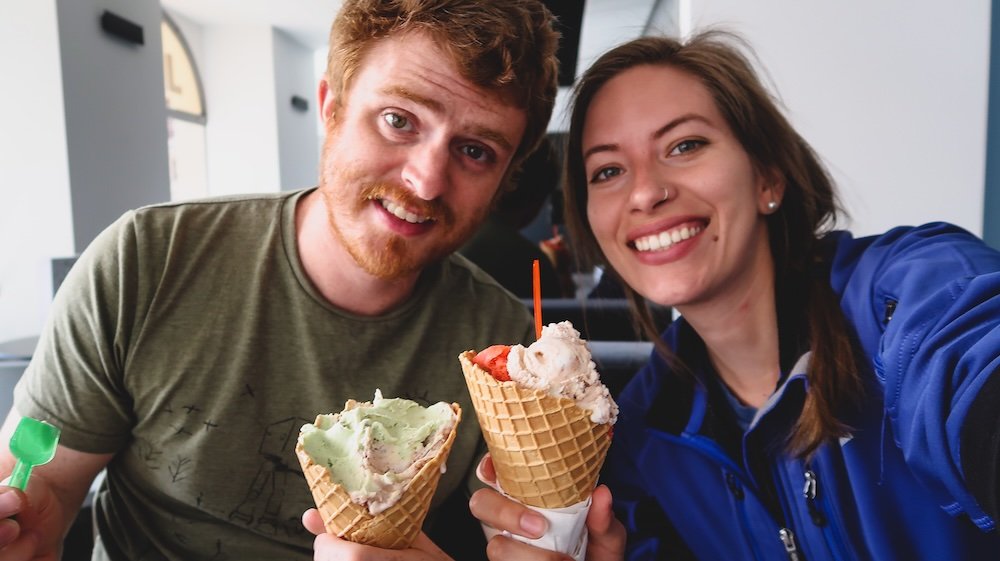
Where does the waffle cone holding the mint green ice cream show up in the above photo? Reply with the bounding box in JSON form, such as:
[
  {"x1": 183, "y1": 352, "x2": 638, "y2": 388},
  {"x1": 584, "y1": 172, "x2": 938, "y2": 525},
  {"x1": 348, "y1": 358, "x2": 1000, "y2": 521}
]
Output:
[{"x1": 295, "y1": 403, "x2": 462, "y2": 549}]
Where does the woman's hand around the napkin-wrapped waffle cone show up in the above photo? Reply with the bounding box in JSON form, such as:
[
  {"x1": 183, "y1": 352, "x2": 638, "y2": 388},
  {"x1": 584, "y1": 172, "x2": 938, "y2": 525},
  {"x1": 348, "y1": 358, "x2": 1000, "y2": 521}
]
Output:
[{"x1": 469, "y1": 454, "x2": 625, "y2": 561}]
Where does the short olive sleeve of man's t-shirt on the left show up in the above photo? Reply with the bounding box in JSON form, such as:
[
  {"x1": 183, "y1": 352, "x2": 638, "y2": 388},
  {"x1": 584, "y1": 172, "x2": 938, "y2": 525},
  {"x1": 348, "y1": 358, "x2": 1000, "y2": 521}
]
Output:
[{"x1": 14, "y1": 213, "x2": 145, "y2": 453}]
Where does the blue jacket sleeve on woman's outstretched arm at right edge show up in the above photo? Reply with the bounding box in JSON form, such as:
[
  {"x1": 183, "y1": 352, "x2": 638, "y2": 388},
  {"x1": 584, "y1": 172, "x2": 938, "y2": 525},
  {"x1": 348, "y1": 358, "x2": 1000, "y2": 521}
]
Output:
[{"x1": 834, "y1": 223, "x2": 1000, "y2": 530}]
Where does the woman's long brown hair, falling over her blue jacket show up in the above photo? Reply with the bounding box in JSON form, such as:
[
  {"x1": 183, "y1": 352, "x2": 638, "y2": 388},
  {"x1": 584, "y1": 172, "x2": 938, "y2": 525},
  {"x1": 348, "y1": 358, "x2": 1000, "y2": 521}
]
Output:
[{"x1": 564, "y1": 30, "x2": 861, "y2": 457}]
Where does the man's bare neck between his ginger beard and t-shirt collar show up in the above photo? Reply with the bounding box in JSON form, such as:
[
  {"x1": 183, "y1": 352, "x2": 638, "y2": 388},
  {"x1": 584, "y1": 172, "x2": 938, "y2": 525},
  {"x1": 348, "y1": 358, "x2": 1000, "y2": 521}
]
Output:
[{"x1": 295, "y1": 190, "x2": 419, "y2": 316}]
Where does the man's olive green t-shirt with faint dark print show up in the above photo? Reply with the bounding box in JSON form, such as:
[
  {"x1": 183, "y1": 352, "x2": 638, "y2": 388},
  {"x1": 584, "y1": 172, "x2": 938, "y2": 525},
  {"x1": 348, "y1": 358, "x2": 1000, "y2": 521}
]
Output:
[{"x1": 15, "y1": 191, "x2": 533, "y2": 561}]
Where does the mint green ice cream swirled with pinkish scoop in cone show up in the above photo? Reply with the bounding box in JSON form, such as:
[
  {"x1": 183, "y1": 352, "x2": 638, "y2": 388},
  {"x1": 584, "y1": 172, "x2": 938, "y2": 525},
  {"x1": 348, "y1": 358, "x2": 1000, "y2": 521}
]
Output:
[{"x1": 299, "y1": 390, "x2": 456, "y2": 514}]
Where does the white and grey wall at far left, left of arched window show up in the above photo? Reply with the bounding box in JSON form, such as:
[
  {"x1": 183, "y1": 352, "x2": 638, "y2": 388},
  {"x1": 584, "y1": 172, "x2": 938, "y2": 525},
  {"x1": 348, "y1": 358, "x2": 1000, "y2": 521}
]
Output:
[{"x1": 0, "y1": 0, "x2": 169, "y2": 341}]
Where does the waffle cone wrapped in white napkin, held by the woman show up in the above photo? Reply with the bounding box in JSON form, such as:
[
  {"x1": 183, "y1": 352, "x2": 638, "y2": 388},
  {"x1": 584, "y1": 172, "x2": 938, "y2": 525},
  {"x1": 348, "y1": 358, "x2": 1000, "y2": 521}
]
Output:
[{"x1": 458, "y1": 351, "x2": 611, "y2": 508}]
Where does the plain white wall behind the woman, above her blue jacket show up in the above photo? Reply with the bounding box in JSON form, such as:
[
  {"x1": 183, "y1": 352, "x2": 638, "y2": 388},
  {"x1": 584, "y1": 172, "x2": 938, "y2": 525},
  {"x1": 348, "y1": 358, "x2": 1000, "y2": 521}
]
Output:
[{"x1": 682, "y1": 0, "x2": 990, "y2": 235}]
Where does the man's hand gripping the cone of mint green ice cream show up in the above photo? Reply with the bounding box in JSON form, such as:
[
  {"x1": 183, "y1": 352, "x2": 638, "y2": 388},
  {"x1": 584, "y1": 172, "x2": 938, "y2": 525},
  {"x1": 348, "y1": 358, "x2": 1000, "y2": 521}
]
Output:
[{"x1": 302, "y1": 508, "x2": 452, "y2": 561}]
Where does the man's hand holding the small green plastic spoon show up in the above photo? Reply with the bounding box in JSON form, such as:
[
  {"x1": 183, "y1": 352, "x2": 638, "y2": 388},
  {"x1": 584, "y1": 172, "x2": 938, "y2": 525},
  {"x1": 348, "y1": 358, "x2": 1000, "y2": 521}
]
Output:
[{"x1": 0, "y1": 474, "x2": 65, "y2": 561}]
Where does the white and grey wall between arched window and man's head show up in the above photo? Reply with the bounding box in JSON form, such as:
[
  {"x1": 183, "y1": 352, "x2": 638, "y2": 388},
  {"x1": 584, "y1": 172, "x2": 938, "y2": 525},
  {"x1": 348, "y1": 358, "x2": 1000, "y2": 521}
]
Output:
[{"x1": 167, "y1": 14, "x2": 325, "y2": 195}]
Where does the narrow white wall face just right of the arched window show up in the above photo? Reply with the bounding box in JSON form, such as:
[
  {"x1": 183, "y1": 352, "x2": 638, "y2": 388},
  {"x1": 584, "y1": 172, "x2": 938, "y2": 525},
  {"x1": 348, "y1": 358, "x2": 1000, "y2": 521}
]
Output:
[{"x1": 200, "y1": 25, "x2": 281, "y2": 195}]
